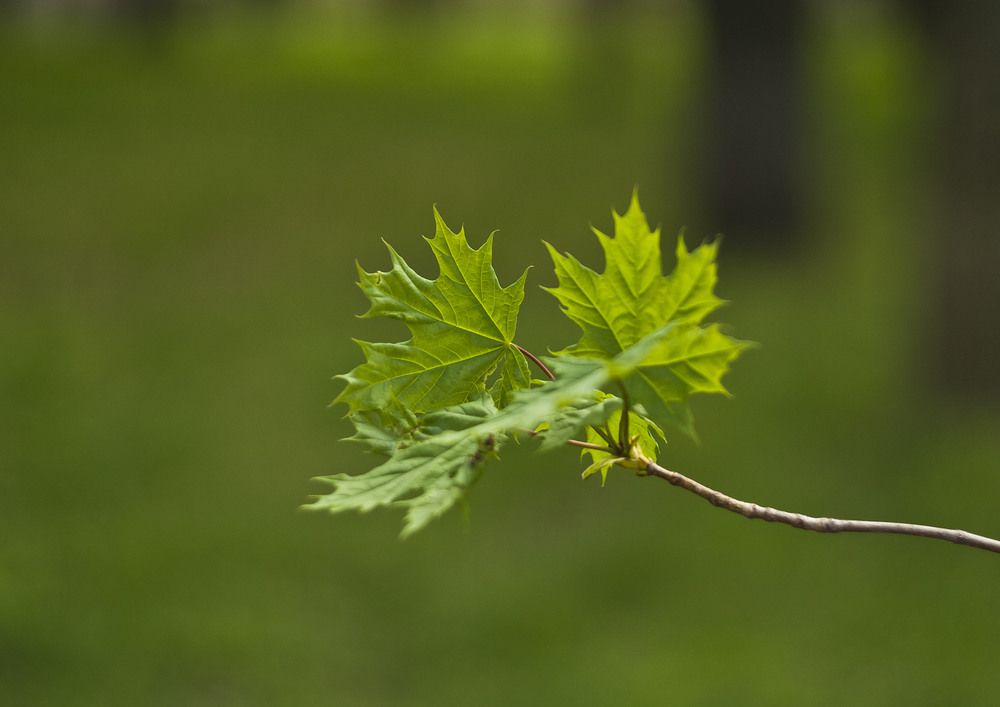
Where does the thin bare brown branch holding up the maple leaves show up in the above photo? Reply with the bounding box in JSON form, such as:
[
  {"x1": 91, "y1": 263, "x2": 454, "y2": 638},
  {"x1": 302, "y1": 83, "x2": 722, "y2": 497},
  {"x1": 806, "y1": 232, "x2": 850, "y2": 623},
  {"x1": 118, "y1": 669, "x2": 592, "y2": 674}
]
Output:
[{"x1": 644, "y1": 460, "x2": 1000, "y2": 553}]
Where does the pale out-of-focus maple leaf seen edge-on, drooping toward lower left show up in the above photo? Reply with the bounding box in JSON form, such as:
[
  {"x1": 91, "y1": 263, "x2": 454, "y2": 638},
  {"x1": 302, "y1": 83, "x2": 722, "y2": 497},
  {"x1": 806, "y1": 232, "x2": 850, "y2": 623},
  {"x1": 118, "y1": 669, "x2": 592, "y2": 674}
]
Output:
[{"x1": 312, "y1": 324, "x2": 744, "y2": 536}]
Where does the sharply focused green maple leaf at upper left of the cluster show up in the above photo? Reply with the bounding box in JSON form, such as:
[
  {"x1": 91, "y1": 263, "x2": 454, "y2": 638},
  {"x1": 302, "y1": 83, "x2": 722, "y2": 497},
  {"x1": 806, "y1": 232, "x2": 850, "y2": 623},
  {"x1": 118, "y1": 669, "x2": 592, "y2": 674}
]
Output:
[{"x1": 334, "y1": 209, "x2": 530, "y2": 413}]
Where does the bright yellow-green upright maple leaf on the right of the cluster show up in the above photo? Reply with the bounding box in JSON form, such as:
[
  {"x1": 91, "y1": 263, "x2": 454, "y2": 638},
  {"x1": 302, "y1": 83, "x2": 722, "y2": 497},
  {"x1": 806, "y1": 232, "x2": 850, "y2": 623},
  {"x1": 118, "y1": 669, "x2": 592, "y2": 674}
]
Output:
[{"x1": 545, "y1": 194, "x2": 748, "y2": 436}]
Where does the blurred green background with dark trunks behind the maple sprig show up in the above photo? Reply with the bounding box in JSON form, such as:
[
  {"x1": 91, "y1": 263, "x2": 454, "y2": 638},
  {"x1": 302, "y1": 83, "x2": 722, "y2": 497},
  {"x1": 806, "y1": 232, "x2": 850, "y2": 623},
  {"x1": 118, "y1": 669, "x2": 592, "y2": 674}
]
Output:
[{"x1": 0, "y1": 0, "x2": 1000, "y2": 706}]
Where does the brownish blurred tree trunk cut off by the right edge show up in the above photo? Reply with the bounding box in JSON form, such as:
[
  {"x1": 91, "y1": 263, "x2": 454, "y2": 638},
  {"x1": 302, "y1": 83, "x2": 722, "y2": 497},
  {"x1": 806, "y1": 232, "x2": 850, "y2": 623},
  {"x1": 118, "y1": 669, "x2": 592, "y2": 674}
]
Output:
[{"x1": 912, "y1": 0, "x2": 1000, "y2": 403}]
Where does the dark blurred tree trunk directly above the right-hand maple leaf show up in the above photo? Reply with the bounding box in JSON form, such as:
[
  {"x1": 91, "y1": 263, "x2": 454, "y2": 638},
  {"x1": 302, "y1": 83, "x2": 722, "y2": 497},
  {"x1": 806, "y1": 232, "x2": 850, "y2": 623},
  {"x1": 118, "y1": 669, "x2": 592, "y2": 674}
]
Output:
[{"x1": 705, "y1": 0, "x2": 805, "y2": 249}]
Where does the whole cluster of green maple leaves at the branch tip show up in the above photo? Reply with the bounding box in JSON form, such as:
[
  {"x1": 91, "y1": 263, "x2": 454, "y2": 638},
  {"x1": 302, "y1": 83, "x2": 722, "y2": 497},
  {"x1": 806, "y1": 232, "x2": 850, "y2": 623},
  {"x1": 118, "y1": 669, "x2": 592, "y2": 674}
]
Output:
[{"x1": 314, "y1": 197, "x2": 747, "y2": 536}]
